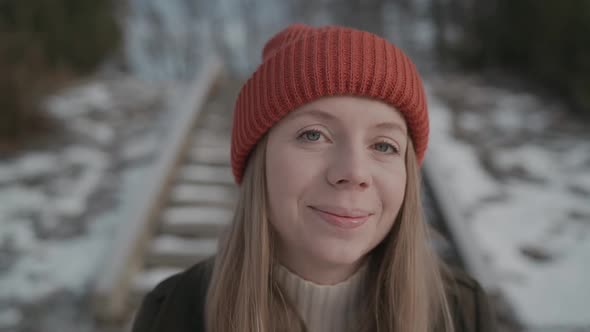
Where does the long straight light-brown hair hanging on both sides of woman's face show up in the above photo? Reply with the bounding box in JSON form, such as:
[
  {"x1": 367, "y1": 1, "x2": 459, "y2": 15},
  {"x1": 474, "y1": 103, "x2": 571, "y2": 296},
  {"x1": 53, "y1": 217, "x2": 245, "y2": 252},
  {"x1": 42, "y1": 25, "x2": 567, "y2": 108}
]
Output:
[{"x1": 205, "y1": 136, "x2": 454, "y2": 332}]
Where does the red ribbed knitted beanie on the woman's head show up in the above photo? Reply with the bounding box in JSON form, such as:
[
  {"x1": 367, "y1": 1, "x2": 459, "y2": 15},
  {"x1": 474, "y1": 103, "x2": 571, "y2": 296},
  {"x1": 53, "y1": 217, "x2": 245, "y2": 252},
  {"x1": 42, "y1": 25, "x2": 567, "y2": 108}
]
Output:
[{"x1": 231, "y1": 24, "x2": 429, "y2": 184}]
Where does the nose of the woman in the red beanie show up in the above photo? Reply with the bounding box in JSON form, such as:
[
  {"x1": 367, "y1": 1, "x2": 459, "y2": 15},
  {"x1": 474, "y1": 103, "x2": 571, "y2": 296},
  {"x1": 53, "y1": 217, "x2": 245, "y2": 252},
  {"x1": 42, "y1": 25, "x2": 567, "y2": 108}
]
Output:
[{"x1": 326, "y1": 147, "x2": 371, "y2": 190}]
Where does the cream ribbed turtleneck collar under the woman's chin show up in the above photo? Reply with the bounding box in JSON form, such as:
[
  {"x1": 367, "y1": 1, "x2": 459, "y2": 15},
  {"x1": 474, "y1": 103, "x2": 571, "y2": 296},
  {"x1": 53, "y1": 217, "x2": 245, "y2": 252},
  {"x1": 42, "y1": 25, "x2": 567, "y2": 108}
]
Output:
[{"x1": 275, "y1": 264, "x2": 367, "y2": 332}]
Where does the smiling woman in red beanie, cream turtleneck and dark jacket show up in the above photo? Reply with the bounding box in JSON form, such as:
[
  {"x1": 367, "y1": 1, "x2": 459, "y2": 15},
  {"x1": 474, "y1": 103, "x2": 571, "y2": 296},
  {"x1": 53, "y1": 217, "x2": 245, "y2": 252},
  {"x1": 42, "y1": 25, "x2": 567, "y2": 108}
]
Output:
[{"x1": 134, "y1": 24, "x2": 494, "y2": 332}]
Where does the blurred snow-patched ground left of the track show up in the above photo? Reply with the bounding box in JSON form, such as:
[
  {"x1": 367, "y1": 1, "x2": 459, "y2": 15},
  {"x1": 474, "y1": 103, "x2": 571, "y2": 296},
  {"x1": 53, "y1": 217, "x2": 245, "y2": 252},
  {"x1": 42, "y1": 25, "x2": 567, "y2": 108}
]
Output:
[{"x1": 0, "y1": 75, "x2": 185, "y2": 331}]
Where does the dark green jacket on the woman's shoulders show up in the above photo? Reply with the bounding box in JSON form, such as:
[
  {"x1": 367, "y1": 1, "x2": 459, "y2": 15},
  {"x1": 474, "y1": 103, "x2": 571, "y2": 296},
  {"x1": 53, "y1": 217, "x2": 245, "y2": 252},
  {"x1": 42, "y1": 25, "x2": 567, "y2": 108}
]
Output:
[{"x1": 132, "y1": 259, "x2": 496, "y2": 332}]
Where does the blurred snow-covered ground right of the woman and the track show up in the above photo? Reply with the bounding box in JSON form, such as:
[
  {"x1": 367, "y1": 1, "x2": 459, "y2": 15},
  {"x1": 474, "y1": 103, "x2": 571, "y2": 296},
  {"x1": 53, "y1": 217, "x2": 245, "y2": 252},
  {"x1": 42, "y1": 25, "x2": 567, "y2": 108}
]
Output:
[{"x1": 428, "y1": 75, "x2": 590, "y2": 331}]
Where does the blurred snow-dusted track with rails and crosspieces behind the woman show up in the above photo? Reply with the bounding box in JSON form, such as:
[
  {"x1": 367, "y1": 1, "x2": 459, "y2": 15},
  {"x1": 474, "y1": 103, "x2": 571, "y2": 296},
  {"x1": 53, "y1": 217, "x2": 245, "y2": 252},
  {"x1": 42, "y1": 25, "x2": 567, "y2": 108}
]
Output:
[{"x1": 93, "y1": 58, "x2": 508, "y2": 324}]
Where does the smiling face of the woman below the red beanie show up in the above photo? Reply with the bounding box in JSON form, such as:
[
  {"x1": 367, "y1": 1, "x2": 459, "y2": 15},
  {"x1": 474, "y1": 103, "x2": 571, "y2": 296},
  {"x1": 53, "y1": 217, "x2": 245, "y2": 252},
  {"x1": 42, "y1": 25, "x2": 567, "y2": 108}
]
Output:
[{"x1": 266, "y1": 96, "x2": 407, "y2": 280}]
